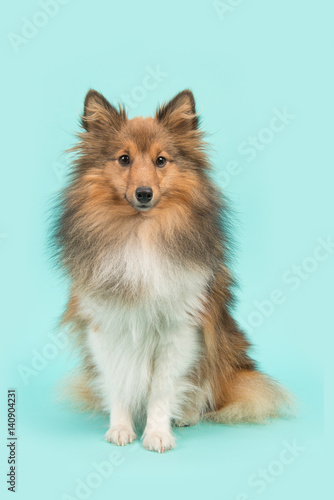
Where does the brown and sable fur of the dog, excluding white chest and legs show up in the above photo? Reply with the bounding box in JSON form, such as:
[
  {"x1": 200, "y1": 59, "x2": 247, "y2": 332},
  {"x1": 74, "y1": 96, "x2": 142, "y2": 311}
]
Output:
[{"x1": 55, "y1": 91, "x2": 291, "y2": 425}]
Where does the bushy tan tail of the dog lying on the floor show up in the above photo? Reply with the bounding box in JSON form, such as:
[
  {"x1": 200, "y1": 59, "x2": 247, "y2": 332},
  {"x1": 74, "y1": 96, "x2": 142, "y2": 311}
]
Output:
[{"x1": 204, "y1": 370, "x2": 296, "y2": 424}]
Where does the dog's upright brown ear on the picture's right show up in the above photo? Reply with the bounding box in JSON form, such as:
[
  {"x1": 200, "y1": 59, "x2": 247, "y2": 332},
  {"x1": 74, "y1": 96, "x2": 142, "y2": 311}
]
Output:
[{"x1": 156, "y1": 90, "x2": 198, "y2": 133}]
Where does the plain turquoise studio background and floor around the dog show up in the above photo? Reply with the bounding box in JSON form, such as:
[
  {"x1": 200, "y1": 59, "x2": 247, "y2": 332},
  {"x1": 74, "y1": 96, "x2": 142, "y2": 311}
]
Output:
[{"x1": 0, "y1": 0, "x2": 328, "y2": 500}]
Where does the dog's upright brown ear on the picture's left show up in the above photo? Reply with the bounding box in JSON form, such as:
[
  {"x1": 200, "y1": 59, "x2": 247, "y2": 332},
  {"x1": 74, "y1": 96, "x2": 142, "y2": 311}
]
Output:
[{"x1": 82, "y1": 89, "x2": 127, "y2": 132}]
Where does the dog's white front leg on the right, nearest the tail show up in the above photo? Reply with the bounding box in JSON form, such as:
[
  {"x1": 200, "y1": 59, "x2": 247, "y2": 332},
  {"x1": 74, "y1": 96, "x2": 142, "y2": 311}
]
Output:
[{"x1": 143, "y1": 327, "x2": 199, "y2": 453}]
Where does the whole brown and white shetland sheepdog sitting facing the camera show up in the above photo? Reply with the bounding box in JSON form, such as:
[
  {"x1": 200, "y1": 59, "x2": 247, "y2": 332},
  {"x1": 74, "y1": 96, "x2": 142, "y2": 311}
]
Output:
[{"x1": 53, "y1": 90, "x2": 291, "y2": 453}]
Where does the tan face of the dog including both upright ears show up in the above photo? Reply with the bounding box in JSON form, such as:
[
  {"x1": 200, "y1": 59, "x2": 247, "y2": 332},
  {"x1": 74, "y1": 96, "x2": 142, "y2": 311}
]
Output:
[{"x1": 80, "y1": 90, "x2": 204, "y2": 214}]
